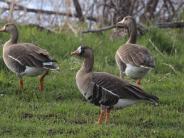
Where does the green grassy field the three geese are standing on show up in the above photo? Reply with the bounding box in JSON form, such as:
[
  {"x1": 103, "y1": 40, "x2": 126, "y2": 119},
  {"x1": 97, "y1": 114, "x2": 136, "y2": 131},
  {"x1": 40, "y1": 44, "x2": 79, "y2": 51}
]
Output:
[{"x1": 0, "y1": 26, "x2": 184, "y2": 138}]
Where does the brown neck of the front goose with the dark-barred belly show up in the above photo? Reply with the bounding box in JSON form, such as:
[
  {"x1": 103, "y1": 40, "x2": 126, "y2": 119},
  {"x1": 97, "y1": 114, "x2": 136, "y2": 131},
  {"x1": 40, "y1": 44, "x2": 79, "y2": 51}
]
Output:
[{"x1": 81, "y1": 53, "x2": 94, "y2": 73}]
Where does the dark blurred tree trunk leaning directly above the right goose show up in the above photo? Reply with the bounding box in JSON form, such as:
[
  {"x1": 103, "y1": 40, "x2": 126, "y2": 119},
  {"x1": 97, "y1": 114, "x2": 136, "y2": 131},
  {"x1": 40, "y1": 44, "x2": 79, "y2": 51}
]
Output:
[{"x1": 140, "y1": 0, "x2": 159, "y2": 23}]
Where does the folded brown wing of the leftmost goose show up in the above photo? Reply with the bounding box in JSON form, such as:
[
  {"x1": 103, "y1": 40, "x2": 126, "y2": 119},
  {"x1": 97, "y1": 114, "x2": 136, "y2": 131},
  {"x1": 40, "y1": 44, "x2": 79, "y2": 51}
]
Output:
[{"x1": 8, "y1": 43, "x2": 58, "y2": 69}]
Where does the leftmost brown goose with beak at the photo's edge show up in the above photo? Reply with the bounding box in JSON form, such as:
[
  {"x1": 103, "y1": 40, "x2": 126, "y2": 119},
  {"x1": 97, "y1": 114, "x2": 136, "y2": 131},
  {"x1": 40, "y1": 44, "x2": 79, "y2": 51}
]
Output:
[{"x1": 0, "y1": 23, "x2": 59, "y2": 91}]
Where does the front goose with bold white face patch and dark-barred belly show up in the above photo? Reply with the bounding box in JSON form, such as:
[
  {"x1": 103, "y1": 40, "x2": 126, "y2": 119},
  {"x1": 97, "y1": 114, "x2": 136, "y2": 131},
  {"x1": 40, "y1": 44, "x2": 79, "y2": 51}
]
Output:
[{"x1": 71, "y1": 46, "x2": 158, "y2": 124}]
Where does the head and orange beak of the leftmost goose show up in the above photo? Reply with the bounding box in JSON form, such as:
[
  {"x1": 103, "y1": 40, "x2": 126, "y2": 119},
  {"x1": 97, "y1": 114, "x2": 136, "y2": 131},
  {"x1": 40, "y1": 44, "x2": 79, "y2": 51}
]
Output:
[{"x1": 0, "y1": 23, "x2": 17, "y2": 33}]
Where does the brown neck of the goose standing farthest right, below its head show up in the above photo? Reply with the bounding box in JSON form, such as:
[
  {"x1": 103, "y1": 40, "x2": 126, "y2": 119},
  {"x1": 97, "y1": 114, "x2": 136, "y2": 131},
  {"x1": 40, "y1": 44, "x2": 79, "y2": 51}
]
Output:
[{"x1": 127, "y1": 21, "x2": 137, "y2": 44}]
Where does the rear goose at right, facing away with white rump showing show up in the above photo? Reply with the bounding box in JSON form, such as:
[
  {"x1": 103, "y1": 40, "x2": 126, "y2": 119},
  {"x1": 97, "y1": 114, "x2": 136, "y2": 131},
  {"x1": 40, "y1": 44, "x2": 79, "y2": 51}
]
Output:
[{"x1": 115, "y1": 16, "x2": 155, "y2": 85}]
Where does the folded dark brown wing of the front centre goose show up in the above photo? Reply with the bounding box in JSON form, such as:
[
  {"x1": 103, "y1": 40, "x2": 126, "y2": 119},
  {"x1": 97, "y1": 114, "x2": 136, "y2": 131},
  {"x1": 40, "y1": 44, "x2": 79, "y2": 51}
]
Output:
[{"x1": 92, "y1": 72, "x2": 158, "y2": 105}]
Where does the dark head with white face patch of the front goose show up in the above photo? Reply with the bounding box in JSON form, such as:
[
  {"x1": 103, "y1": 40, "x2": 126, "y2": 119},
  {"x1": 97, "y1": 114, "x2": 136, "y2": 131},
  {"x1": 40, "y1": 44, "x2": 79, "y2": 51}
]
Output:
[{"x1": 71, "y1": 45, "x2": 93, "y2": 58}]
